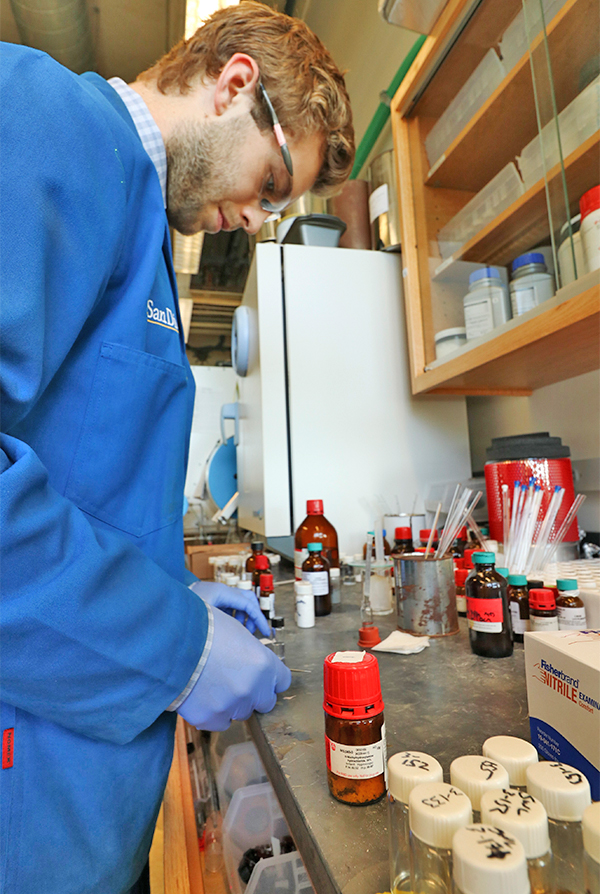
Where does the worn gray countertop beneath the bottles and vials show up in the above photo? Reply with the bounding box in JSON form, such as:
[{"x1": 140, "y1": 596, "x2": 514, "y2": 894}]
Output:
[{"x1": 248, "y1": 584, "x2": 530, "y2": 894}]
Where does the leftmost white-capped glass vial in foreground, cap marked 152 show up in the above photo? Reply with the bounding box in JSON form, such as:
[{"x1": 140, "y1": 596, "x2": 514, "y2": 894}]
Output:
[{"x1": 388, "y1": 751, "x2": 444, "y2": 894}]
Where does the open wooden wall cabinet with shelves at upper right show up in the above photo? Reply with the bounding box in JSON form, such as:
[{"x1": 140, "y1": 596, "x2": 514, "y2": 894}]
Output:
[{"x1": 392, "y1": 0, "x2": 600, "y2": 394}]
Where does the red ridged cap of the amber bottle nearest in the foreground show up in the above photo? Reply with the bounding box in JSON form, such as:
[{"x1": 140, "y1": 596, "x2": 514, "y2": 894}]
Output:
[{"x1": 323, "y1": 652, "x2": 383, "y2": 720}]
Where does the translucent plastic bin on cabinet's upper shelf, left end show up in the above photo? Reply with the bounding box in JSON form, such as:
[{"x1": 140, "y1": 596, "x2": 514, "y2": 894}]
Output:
[{"x1": 425, "y1": 50, "x2": 506, "y2": 167}]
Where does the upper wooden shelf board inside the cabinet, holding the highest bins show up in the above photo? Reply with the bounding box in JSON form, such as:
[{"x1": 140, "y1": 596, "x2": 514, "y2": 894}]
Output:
[{"x1": 425, "y1": 0, "x2": 600, "y2": 192}]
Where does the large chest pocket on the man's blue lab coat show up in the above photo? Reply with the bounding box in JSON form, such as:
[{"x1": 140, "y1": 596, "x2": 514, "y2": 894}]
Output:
[{"x1": 65, "y1": 342, "x2": 191, "y2": 537}]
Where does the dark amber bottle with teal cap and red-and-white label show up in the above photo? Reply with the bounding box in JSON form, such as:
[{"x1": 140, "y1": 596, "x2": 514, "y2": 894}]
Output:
[{"x1": 465, "y1": 552, "x2": 513, "y2": 658}]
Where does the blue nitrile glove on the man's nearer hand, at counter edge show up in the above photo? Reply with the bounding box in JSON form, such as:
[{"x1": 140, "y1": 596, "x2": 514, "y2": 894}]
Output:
[{"x1": 177, "y1": 609, "x2": 292, "y2": 732}]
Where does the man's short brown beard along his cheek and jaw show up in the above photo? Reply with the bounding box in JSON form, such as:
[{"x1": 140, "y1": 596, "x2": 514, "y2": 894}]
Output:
[{"x1": 165, "y1": 115, "x2": 252, "y2": 236}]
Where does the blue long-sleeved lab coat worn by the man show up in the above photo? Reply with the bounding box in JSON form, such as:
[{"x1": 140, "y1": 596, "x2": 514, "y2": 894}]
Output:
[{"x1": 0, "y1": 44, "x2": 208, "y2": 894}]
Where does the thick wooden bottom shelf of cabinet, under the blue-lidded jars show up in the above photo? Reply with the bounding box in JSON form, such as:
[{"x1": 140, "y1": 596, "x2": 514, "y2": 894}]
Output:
[{"x1": 413, "y1": 272, "x2": 600, "y2": 394}]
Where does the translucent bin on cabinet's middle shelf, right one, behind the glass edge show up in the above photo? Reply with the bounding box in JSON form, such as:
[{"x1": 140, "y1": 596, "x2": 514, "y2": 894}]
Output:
[{"x1": 517, "y1": 77, "x2": 600, "y2": 189}]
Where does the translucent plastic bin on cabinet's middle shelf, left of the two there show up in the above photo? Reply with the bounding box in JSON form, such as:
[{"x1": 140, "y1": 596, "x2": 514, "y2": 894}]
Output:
[{"x1": 438, "y1": 161, "x2": 525, "y2": 258}]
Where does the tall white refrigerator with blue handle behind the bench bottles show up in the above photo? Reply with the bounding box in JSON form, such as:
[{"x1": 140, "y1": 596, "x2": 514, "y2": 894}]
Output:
[{"x1": 225, "y1": 243, "x2": 471, "y2": 556}]
